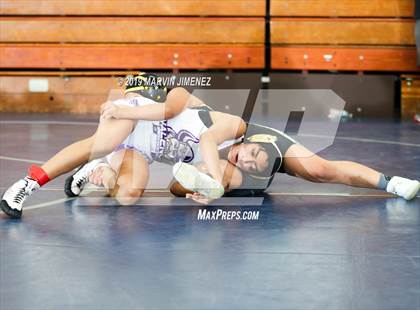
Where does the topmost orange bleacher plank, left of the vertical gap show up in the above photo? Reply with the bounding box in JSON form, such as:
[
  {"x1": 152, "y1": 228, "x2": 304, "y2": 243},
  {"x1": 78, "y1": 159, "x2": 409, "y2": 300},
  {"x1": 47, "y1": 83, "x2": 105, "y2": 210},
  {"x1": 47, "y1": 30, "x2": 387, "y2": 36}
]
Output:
[{"x1": 0, "y1": 0, "x2": 265, "y2": 16}]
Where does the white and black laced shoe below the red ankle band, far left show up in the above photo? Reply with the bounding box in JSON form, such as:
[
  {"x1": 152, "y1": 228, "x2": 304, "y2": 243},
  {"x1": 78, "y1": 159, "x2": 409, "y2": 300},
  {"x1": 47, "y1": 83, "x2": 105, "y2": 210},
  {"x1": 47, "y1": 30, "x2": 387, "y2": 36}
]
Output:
[{"x1": 0, "y1": 177, "x2": 39, "y2": 218}]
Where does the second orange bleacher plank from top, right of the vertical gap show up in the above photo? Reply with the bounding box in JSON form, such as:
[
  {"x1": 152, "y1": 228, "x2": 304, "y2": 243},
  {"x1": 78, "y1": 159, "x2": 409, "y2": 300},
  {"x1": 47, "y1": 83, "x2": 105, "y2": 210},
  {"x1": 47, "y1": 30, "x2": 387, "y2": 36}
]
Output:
[{"x1": 271, "y1": 18, "x2": 415, "y2": 45}]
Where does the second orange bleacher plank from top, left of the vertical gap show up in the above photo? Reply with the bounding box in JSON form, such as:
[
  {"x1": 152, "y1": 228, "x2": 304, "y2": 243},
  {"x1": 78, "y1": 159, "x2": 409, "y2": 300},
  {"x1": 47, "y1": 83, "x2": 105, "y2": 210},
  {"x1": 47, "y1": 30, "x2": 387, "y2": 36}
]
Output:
[{"x1": 0, "y1": 17, "x2": 264, "y2": 43}]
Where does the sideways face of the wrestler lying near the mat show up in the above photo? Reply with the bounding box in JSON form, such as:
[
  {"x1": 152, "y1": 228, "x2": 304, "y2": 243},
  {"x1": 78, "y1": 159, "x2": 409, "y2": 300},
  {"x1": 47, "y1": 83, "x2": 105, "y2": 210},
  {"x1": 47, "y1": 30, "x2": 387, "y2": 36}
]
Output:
[{"x1": 228, "y1": 143, "x2": 268, "y2": 173}]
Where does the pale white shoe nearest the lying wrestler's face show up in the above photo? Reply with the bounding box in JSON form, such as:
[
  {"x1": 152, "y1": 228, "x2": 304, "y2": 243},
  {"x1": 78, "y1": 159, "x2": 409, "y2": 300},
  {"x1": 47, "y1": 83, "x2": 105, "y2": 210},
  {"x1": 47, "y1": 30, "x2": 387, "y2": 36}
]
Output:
[{"x1": 172, "y1": 162, "x2": 225, "y2": 199}]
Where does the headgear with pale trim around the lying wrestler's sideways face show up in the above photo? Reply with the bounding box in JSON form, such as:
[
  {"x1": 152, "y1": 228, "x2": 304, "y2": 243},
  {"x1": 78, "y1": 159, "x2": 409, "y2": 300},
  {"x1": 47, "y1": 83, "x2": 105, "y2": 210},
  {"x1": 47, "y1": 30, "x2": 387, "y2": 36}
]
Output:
[{"x1": 246, "y1": 134, "x2": 283, "y2": 180}]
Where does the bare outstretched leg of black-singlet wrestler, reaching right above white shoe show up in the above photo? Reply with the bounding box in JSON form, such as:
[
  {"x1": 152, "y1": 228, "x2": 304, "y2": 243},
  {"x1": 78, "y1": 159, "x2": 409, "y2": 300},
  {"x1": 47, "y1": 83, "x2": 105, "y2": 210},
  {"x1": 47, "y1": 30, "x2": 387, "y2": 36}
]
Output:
[{"x1": 284, "y1": 144, "x2": 382, "y2": 188}]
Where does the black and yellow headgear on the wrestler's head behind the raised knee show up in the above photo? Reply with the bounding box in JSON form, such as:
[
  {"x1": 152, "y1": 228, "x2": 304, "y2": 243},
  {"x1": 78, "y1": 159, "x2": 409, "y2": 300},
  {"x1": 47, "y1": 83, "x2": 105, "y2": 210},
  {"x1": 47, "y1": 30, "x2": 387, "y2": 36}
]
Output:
[{"x1": 125, "y1": 72, "x2": 168, "y2": 102}]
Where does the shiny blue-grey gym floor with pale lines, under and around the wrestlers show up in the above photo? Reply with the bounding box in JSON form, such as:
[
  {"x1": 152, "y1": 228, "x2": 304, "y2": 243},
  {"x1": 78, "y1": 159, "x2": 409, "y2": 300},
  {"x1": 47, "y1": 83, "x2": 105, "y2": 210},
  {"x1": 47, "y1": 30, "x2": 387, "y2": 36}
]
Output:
[{"x1": 0, "y1": 114, "x2": 420, "y2": 310}]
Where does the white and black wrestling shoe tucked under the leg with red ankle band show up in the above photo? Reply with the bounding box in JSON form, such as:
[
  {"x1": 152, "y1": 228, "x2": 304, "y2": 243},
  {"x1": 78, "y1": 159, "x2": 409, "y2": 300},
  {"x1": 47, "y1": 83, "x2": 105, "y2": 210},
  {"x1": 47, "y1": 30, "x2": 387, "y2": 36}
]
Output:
[{"x1": 64, "y1": 159, "x2": 106, "y2": 197}]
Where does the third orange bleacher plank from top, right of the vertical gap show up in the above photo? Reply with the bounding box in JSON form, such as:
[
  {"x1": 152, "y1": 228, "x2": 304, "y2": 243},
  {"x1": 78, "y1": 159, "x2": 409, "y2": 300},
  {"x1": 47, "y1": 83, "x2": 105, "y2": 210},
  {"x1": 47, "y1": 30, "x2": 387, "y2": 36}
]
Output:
[{"x1": 271, "y1": 46, "x2": 420, "y2": 72}]
